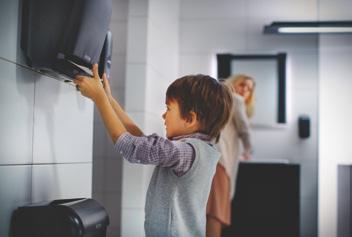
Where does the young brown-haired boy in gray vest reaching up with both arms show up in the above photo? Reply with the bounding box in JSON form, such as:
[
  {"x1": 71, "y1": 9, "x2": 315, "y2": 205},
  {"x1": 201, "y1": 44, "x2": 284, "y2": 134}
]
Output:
[{"x1": 74, "y1": 65, "x2": 232, "y2": 237}]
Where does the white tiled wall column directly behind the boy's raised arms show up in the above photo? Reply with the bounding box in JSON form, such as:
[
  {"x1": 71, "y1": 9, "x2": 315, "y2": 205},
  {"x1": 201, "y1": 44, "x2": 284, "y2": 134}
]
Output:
[{"x1": 121, "y1": 0, "x2": 179, "y2": 237}]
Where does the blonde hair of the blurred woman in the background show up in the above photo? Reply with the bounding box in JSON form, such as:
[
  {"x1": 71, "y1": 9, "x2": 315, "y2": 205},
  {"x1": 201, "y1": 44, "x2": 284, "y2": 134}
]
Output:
[{"x1": 225, "y1": 74, "x2": 255, "y2": 118}]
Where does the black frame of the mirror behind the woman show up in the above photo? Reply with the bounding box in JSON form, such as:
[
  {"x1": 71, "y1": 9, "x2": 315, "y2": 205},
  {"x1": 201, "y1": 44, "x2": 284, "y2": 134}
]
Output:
[{"x1": 216, "y1": 53, "x2": 286, "y2": 124}]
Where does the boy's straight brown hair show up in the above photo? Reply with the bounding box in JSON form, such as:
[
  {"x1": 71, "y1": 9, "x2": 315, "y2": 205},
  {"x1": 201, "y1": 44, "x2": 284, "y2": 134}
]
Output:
[{"x1": 166, "y1": 74, "x2": 232, "y2": 140}]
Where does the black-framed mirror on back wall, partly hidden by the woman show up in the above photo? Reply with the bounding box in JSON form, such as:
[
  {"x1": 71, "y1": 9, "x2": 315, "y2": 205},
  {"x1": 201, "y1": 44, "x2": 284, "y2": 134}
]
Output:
[{"x1": 217, "y1": 53, "x2": 286, "y2": 126}]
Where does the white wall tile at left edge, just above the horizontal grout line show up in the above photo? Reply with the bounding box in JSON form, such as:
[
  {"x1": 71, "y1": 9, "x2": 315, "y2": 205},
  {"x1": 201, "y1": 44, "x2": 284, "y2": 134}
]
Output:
[{"x1": 0, "y1": 59, "x2": 37, "y2": 164}]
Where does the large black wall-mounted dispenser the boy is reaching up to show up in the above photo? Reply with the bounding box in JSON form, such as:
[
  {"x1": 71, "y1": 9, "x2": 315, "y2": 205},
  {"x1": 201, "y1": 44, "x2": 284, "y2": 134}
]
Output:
[{"x1": 21, "y1": 0, "x2": 112, "y2": 79}]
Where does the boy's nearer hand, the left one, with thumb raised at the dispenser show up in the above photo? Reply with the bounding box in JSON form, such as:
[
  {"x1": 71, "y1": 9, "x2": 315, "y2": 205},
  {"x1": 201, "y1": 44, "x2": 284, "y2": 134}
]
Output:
[{"x1": 73, "y1": 64, "x2": 105, "y2": 102}]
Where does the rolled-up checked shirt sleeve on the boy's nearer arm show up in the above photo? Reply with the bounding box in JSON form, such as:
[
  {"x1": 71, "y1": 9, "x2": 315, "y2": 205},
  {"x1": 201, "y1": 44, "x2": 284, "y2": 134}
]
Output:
[{"x1": 115, "y1": 132, "x2": 195, "y2": 176}]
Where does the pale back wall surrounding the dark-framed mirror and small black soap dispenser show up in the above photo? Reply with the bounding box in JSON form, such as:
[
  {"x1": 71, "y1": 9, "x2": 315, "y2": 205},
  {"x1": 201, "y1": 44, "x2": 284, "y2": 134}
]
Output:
[{"x1": 179, "y1": 0, "x2": 318, "y2": 237}]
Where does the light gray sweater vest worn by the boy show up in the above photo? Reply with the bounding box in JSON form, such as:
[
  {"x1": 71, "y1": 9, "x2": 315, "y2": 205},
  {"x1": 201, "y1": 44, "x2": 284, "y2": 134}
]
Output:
[{"x1": 144, "y1": 138, "x2": 220, "y2": 237}]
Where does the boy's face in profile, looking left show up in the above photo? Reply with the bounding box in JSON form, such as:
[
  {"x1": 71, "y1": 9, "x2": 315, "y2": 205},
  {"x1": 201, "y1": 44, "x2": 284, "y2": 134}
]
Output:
[{"x1": 163, "y1": 100, "x2": 189, "y2": 139}]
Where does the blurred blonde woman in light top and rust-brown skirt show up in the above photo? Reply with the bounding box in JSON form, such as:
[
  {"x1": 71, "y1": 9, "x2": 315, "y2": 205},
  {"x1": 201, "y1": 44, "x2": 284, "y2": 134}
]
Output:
[{"x1": 206, "y1": 74, "x2": 255, "y2": 237}]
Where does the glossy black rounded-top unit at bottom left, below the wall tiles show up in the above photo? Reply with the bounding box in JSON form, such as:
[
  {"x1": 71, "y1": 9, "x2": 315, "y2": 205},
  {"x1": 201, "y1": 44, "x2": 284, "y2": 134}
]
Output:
[{"x1": 11, "y1": 198, "x2": 109, "y2": 237}]
